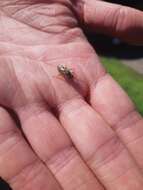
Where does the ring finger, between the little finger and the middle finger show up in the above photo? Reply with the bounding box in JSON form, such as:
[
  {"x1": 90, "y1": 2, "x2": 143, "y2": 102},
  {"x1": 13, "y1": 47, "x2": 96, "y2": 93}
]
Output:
[{"x1": 17, "y1": 104, "x2": 103, "y2": 190}]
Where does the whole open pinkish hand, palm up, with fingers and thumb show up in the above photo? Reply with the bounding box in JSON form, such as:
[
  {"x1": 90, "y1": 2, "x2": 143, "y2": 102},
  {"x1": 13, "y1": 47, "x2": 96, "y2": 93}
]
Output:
[{"x1": 0, "y1": 0, "x2": 143, "y2": 190}]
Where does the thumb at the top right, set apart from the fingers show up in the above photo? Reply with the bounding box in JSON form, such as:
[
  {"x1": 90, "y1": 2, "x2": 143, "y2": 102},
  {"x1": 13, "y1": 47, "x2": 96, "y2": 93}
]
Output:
[{"x1": 77, "y1": 0, "x2": 143, "y2": 44}]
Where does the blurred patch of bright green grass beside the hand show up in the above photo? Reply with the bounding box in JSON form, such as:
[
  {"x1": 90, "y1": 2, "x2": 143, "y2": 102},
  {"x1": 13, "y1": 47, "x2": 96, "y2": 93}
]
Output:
[{"x1": 101, "y1": 57, "x2": 143, "y2": 115}]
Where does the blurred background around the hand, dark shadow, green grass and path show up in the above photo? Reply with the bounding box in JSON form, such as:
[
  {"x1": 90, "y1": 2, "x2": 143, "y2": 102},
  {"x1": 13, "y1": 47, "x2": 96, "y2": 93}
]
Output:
[{"x1": 0, "y1": 0, "x2": 143, "y2": 190}]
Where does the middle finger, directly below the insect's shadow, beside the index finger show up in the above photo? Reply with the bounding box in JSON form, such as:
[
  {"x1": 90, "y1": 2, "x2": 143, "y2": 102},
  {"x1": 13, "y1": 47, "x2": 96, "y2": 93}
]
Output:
[{"x1": 60, "y1": 99, "x2": 143, "y2": 190}]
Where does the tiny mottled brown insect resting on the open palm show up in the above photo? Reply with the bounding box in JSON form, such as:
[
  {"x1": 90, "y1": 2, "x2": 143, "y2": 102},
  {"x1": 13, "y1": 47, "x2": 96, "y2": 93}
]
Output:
[{"x1": 57, "y1": 65, "x2": 74, "y2": 79}]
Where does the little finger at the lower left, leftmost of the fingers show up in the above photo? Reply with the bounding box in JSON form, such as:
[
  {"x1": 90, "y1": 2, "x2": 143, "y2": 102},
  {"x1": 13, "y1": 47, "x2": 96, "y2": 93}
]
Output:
[{"x1": 0, "y1": 107, "x2": 61, "y2": 190}]
